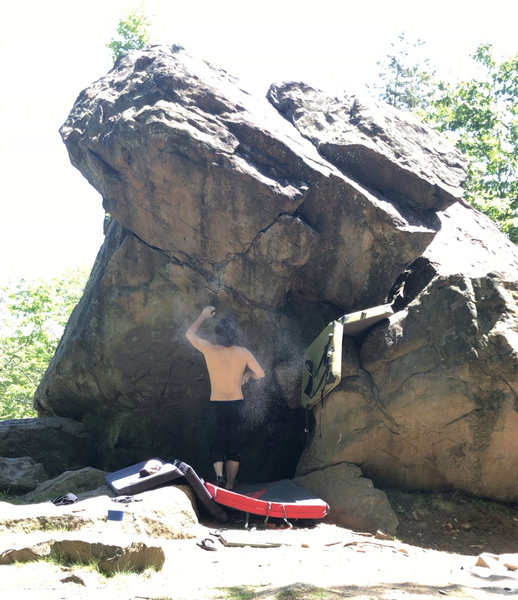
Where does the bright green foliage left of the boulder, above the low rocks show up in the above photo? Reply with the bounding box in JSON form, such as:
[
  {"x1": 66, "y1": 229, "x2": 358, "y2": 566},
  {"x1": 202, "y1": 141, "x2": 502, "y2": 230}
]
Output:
[{"x1": 0, "y1": 268, "x2": 87, "y2": 419}]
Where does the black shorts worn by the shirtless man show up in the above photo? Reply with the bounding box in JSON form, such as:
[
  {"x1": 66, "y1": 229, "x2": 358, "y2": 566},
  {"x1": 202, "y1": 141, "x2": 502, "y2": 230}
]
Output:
[{"x1": 207, "y1": 400, "x2": 244, "y2": 464}]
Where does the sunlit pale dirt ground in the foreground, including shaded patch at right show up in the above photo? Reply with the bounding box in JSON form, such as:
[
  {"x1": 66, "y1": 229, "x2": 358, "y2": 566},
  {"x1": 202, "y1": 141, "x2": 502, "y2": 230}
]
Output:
[{"x1": 0, "y1": 491, "x2": 518, "y2": 600}]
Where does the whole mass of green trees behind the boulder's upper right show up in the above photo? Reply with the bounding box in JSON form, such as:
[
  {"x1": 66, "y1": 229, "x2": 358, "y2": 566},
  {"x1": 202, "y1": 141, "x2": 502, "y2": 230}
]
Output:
[{"x1": 373, "y1": 33, "x2": 518, "y2": 243}]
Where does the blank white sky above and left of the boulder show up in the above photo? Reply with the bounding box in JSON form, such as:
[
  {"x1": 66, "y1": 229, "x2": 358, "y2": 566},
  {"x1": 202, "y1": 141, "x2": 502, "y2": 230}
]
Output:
[{"x1": 0, "y1": 0, "x2": 518, "y2": 285}]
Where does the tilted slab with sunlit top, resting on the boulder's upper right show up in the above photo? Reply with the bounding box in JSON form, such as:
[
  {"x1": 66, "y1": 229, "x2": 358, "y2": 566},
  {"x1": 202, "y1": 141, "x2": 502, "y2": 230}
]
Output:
[{"x1": 268, "y1": 83, "x2": 465, "y2": 212}]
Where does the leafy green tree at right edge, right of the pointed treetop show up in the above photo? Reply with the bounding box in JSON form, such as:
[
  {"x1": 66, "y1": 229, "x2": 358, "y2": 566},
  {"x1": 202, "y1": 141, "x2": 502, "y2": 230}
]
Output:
[{"x1": 424, "y1": 45, "x2": 518, "y2": 243}]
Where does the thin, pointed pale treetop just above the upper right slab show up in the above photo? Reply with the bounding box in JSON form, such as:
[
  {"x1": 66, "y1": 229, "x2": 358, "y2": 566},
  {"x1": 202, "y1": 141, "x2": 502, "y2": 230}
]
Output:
[{"x1": 371, "y1": 32, "x2": 435, "y2": 110}]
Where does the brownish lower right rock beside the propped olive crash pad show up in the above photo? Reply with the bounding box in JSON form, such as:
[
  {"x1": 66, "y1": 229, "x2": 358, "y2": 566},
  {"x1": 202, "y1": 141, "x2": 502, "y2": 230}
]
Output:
[{"x1": 298, "y1": 206, "x2": 518, "y2": 502}]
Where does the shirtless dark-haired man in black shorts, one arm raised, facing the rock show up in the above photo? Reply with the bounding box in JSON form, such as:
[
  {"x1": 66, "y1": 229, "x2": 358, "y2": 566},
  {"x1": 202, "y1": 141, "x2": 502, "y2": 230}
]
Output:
[{"x1": 185, "y1": 306, "x2": 265, "y2": 490}]
